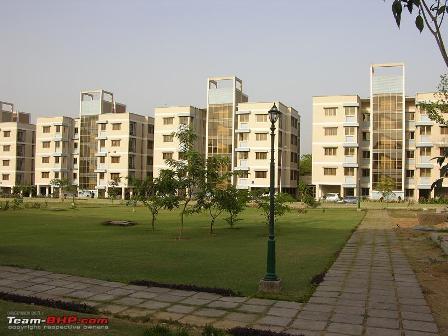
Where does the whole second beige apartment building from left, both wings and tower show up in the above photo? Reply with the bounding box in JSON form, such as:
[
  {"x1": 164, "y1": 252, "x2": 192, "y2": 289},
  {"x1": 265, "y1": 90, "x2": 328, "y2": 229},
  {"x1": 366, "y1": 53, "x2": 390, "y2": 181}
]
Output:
[{"x1": 36, "y1": 90, "x2": 154, "y2": 199}]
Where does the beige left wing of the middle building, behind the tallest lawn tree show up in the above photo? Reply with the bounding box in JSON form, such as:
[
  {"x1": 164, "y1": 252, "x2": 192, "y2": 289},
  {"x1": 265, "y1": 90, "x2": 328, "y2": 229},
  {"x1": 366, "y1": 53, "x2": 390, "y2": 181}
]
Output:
[{"x1": 154, "y1": 106, "x2": 206, "y2": 177}]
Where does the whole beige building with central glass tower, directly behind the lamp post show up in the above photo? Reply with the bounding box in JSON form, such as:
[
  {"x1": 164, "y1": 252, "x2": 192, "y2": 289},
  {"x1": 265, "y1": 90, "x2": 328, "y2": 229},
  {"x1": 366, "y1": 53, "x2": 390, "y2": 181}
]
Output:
[{"x1": 154, "y1": 77, "x2": 300, "y2": 194}]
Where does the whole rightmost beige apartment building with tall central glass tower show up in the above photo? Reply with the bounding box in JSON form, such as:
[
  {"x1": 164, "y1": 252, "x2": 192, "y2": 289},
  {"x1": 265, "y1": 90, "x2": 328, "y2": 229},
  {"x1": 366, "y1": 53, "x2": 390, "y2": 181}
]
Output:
[{"x1": 312, "y1": 63, "x2": 440, "y2": 200}]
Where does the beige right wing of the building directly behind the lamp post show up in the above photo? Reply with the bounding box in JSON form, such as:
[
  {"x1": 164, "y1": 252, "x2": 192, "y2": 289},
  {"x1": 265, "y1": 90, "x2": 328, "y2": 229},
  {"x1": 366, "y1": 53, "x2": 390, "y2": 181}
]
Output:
[{"x1": 233, "y1": 102, "x2": 300, "y2": 195}]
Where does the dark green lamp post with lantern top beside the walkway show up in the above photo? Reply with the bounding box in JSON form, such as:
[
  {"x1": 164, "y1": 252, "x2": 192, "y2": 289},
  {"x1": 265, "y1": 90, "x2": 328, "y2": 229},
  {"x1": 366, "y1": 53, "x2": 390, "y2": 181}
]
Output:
[{"x1": 259, "y1": 103, "x2": 281, "y2": 292}]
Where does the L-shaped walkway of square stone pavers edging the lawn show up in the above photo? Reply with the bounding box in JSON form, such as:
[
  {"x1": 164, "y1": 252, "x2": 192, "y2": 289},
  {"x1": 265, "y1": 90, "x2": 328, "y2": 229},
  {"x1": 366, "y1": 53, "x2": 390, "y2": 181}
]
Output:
[{"x1": 0, "y1": 210, "x2": 437, "y2": 336}]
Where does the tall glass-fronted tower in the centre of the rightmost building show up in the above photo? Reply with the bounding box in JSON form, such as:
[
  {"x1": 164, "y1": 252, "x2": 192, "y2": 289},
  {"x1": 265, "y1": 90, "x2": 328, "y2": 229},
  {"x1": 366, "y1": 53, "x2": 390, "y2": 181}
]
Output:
[{"x1": 371, "y1": 66, "x2": 404, "y2": 192}]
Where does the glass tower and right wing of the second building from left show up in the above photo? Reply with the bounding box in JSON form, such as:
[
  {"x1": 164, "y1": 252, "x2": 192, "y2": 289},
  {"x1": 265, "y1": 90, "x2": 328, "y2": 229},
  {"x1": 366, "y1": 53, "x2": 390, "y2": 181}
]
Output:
[{"x1": 78, "y1": 90, "x2": 154, "y2": 198}]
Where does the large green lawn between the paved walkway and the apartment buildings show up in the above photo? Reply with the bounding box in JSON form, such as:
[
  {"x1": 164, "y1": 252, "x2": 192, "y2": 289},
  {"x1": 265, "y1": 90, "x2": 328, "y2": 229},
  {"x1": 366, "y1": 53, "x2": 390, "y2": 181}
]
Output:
[{"x1": 0, "y1": 202, "x2": 364, "y2": 301}]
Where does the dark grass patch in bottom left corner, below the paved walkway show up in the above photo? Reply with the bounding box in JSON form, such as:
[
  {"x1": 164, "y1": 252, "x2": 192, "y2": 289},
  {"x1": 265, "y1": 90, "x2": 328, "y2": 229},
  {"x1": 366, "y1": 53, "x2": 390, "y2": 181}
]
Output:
[{"x1": 0, "y1": 300, "x2": 148, "y2": 336}]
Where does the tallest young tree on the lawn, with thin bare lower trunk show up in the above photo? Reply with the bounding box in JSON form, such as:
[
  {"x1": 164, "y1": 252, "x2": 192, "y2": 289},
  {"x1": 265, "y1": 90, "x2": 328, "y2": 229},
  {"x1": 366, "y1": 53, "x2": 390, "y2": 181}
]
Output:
[{"x1": 166, "y1": 126, "x2": 206, "y2": 239}]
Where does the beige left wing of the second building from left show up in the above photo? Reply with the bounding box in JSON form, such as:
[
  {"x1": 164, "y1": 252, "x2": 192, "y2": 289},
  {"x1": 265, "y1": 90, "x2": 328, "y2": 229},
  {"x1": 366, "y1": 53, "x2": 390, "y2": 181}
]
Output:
[{"x1": 35, "y1": 117, "x2": 79, "y2": 196}]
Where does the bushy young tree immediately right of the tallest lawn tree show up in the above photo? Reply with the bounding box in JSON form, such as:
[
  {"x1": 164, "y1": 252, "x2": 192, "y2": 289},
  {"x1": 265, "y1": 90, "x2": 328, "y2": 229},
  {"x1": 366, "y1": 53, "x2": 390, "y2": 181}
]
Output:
[{"x1": 196, "y1": 156, "x2": 233, "y2": 234}]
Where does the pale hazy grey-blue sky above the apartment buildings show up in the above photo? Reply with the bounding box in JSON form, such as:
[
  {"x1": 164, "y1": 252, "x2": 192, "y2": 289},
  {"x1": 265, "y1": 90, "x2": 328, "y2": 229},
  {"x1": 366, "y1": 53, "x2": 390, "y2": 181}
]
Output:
[{"x1": 0, "y1": 0, "x2": 446, "y2": 153}]
